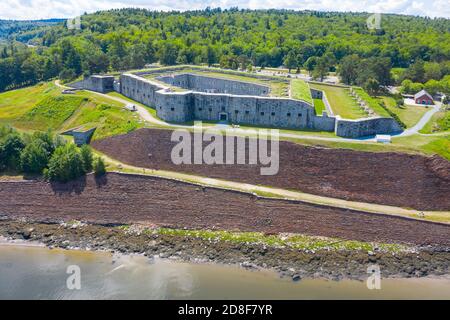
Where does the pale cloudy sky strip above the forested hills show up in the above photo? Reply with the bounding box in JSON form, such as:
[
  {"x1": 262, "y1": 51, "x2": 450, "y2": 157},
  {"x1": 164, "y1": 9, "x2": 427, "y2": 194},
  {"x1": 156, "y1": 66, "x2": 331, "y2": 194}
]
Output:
[{"x1": 0, "y1": 0, "x2": 450, "y2": 20}]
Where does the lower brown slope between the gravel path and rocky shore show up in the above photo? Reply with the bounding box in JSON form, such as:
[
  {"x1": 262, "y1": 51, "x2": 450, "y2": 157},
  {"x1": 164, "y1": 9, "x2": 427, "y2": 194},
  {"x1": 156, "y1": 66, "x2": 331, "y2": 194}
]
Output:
[{"x1": 0, "y1": 173, "x2": 450, "y2": 247}]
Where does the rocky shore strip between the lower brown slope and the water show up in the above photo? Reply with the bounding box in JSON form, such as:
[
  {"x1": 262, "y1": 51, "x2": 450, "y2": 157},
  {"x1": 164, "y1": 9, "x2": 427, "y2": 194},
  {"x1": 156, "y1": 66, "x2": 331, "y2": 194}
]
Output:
[{"x1": 0, "y1": 219, "x2": 450, "y2": 281}]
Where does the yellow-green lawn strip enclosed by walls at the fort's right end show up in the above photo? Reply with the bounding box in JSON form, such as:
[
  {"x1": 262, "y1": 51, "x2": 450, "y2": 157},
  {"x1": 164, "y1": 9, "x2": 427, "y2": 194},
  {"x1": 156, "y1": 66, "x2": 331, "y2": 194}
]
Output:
[{"x1": 310, "y1": 83, "x2": 367, "y2": 119}]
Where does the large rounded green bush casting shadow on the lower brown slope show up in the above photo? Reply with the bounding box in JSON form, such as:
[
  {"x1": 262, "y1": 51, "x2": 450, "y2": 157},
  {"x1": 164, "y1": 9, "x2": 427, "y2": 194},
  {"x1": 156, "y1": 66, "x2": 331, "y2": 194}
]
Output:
[{"x1": 45, "y1": 144, "x2": 86, "y2": 182}]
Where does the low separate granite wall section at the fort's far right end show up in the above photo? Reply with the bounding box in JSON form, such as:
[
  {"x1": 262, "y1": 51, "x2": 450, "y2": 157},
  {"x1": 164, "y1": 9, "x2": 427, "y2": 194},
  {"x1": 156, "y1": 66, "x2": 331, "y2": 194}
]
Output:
[{"x1": 335, "y1": 117, "x2": 402, "y2": 138}]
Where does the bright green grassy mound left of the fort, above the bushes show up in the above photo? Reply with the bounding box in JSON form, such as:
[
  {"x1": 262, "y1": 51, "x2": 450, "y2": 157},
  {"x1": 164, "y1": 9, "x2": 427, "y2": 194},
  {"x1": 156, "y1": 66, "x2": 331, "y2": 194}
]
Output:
[{"x1": 0, "y1": 83, "x2": 144, "y2": 140}]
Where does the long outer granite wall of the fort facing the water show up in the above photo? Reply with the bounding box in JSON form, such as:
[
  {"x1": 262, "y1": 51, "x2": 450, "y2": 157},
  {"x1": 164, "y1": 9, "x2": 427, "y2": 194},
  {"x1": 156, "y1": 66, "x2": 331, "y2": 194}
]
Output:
[{"x1": 120, "y1": 74, "x2": 335, "y2": 131}]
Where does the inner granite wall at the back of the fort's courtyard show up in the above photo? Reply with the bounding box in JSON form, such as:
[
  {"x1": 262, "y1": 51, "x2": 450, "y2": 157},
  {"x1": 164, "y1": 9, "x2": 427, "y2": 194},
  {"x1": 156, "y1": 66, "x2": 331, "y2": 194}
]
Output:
[{"x1": 156, "y1": 73, "x2": 270, "y2": 96}]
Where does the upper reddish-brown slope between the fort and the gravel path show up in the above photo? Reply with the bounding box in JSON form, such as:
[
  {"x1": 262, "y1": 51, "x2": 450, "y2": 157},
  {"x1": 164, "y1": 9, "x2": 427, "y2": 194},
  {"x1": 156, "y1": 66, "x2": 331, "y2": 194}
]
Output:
[{"x1": 93, "y1": 129, "x2": 450, "y2": 210}]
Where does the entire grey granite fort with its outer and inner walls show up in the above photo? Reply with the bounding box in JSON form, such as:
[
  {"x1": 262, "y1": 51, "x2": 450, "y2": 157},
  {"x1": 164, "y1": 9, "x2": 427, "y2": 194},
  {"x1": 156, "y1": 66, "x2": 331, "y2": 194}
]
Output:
[{"x1": 72, "y1": 73, "x2": 401, "y2": 138}]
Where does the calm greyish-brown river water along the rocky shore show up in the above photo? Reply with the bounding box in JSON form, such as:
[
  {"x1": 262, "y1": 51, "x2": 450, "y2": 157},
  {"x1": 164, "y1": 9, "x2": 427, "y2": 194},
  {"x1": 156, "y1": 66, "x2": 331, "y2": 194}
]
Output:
[{"x1": 0, "y1": 243, "x2": 450, "y2": 299}]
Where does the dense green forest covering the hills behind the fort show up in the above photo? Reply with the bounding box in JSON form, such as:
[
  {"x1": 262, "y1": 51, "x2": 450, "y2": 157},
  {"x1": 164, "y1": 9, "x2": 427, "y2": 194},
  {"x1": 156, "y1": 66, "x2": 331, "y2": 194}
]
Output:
[{"x1": 0, "y1": 8, "x2": 450, "y2": 91}]
